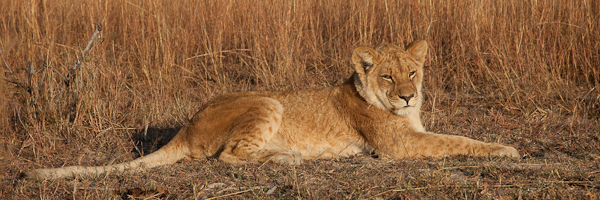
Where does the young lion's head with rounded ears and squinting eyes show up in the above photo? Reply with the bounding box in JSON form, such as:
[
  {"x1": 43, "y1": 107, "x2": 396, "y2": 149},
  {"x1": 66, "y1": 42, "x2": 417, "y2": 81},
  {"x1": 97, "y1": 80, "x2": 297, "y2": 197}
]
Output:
[{"x1": 352, "y1": 41, "x2": 427, "y2": 115}]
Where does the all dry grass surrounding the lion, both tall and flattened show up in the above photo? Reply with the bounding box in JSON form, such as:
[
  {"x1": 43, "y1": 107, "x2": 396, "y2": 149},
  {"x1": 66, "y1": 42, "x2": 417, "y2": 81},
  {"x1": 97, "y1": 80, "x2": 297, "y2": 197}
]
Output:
[{"x1": 0, "y1": 0, "x2": 600, "y2": 199}]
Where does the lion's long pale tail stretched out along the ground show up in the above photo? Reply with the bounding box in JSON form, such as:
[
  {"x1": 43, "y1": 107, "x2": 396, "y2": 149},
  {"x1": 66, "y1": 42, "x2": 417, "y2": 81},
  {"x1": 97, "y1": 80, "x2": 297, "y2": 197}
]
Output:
[{"x1": 23, "y1": 130, "x2": 189, "y2": 180}]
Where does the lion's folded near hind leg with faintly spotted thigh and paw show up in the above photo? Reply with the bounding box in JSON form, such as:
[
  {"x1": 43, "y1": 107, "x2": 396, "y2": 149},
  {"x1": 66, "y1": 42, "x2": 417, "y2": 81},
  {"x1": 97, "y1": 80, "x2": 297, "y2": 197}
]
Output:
[{"x1": 219, "y1": 97, "x2": 302, "y2": 164}]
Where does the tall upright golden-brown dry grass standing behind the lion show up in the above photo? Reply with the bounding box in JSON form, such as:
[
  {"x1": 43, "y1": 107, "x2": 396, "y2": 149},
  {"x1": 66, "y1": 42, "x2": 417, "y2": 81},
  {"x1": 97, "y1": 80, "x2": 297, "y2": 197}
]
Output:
[{"x1": 0, "y1": 0, "x2": 600, "y2": 172}]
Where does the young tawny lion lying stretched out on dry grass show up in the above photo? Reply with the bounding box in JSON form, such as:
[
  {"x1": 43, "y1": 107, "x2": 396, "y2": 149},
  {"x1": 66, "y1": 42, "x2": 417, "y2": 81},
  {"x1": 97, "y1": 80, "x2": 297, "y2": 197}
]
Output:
[{"x1": 24, "y1": 41, "x2": 520, "y2": 179}]
